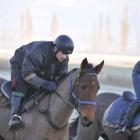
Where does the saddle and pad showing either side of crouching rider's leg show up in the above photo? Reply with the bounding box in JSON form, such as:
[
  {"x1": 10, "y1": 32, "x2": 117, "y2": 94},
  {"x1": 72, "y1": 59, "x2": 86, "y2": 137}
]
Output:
[{"x1": 1, "y1": 81, "x2": 45, "y2": 113}]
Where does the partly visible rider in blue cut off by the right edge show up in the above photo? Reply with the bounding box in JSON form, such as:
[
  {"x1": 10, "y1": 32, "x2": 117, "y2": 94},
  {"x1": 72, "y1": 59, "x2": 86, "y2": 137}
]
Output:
[{"x1": 116, "y1": 61, "x2": 140, "y2": 136}]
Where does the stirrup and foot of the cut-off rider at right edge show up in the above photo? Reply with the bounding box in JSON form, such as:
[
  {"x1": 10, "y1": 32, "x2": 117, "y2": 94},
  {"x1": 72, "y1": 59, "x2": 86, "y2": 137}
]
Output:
[{"x1": 115, "y1": 125, "x2": 132, "y2": 136}]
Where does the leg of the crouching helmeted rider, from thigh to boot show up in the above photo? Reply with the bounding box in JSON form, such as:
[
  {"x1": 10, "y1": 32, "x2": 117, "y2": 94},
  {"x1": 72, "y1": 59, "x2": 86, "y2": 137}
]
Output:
[{"x1": 9, "y1": 72, "x2": 27, "y2": 128}]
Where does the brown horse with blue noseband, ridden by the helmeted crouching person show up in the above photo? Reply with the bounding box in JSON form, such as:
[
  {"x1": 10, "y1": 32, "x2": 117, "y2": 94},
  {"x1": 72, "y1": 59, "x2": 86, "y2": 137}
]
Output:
[{"x1": 0, "y1": 58, "x2": 104, "y2": 140}]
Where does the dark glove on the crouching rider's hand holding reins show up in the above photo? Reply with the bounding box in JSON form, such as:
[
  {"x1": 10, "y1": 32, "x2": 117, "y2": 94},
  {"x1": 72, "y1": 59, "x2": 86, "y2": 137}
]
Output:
[{"x1": 40, "y1": 81, "x2": 56, "y2": 92}]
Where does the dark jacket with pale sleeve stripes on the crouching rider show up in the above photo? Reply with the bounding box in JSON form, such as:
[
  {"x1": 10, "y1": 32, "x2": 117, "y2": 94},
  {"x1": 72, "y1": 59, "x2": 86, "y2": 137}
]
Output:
[{"x1": 11, "y1": 41, "x2": 69, "y2": 89}]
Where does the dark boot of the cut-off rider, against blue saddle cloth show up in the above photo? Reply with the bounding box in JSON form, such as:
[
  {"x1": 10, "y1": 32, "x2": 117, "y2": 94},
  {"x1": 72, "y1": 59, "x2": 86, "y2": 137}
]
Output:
[{"x1": 116, "y1": 102, "x2": 140, "y2": 136}]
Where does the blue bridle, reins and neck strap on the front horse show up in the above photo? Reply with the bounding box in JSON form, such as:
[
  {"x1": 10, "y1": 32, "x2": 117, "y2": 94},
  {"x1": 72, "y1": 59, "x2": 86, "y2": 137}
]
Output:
[{"x1": 46, "y1": 69, "x2": 97, "y2": 129}]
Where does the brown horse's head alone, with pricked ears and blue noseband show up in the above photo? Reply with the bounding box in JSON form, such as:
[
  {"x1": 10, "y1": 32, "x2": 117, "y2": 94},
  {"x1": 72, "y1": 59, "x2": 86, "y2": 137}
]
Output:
[{"x1": 76, "y1": 58, "x2": 104, "y2": 126}]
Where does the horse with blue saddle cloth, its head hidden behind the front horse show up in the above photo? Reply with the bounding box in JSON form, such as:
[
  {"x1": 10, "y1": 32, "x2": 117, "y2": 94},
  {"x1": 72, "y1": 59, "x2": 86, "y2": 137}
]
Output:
[{"x1": 73, "y1": 91, "x2": 140, "y2": 140}]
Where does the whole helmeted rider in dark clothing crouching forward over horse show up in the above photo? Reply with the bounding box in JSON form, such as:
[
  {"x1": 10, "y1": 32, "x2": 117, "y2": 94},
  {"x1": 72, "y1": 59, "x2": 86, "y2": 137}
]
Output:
[{"x1": 9, "y1": 35, "x2": 74, "y2": 128}]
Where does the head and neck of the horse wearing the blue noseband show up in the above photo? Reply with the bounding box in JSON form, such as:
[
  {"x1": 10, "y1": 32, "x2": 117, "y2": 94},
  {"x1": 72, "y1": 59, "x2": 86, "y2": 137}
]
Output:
[{"x1": 39, "y1": 58, "x2": 104, "y2": 129}]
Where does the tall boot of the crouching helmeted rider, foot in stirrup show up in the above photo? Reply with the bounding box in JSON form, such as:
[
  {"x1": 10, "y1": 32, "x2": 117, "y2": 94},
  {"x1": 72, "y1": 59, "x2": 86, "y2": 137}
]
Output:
[{"x1": 9, "y1": 96, "x2": 22, "y2": 129}]
